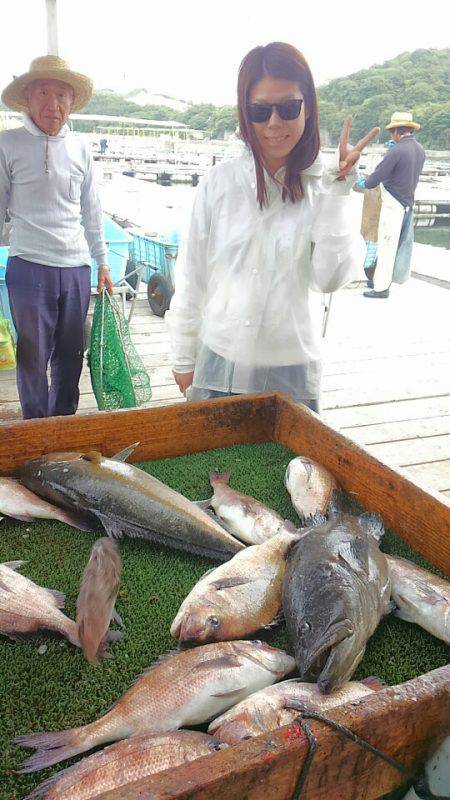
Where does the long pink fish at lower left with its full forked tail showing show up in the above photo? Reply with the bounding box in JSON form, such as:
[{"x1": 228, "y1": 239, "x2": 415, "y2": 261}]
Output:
[{"x1": 15, "y1": 641, "x2": 295, "y2": 772}]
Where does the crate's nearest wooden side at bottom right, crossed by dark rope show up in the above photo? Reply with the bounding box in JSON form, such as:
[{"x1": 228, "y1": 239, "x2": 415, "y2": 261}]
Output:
[{"x1": 92, "y1": 667, "x2": 450, "y2": 800}]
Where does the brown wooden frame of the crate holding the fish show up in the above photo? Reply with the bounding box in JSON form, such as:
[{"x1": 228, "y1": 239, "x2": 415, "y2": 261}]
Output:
[{"x1": 0, "y1": 394, "x2": 450, "y2": 800}]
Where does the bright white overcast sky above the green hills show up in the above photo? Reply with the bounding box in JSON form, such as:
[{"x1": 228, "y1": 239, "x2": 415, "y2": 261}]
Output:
[{"x1": 0, "y1": 0, "x2": 450, "y2": 105}]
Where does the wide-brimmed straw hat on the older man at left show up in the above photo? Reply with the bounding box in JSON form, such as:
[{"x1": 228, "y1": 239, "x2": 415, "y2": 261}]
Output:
[{"x1": 2, "y1": 55, "x2": 93, "y2": 111}]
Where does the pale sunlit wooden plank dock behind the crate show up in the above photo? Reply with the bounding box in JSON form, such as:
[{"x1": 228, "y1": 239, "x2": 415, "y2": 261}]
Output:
[{"x1": 0, "y1": 272, "x2": 450, "y2": 504}]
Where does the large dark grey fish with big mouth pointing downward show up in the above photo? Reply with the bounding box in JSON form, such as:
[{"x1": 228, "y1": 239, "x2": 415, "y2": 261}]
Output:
[{"x1": 282, "y1": 513, "x2": 392, "y2": 693}]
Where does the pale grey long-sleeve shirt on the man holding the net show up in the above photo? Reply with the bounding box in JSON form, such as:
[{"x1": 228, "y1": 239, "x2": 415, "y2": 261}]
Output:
[{"x1": 0, "y1": 114, "x2": 108, "y2": 267}]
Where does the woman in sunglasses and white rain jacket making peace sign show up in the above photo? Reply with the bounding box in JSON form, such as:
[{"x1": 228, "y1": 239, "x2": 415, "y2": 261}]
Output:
[{"x1": 166, "y1": 42, "x2": 379, "y2": 411}]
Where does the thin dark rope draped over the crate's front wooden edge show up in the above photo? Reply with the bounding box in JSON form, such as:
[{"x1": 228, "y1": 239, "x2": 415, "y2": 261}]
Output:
[{"x1": 285, "y1": 701, "x2": 416, "y2": 800}]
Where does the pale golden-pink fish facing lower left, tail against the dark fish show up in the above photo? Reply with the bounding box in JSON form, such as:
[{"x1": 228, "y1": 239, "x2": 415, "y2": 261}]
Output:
[{"x1": 170, "y1": 532, "x2": 298, "y2": 644}]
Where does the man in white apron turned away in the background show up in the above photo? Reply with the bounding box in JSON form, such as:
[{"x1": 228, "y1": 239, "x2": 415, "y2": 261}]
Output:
[{"x1": 356, "y1": 111, "x2": 425, "y2": 299}]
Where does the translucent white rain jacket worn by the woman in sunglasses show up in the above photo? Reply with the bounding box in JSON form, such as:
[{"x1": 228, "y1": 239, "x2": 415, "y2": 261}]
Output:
[{"x1": 166, "y1": 154, "x2": 364, "y2": 399}]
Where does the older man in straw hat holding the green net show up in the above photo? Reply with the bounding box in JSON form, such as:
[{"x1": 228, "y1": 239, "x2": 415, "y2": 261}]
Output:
[{"x1": 0, "y1": 55, "x2": 112, "y2": 419}]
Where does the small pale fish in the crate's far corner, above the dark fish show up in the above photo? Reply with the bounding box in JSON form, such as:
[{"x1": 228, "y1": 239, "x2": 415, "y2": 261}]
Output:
[{"x1": 284, "y1": 456, "x2": 341, "y2": 522}]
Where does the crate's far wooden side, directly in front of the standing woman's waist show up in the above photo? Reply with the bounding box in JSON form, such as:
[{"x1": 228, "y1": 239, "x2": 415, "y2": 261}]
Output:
[{"x1": 0, "y1": 394, "x2": 276, "y2": 475}]
